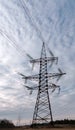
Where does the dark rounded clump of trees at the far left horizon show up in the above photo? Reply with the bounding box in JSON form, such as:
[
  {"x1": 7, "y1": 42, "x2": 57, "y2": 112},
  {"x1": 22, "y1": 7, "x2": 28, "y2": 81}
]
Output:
[{"x1": 0, "y1": 119, "x2": 15, "y2": 128}]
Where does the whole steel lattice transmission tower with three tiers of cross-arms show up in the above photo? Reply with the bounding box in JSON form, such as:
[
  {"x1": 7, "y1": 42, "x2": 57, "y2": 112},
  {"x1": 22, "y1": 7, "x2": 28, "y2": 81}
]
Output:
[{"x1": 19, "y1": 42, "x2": 65, "y2": 124}]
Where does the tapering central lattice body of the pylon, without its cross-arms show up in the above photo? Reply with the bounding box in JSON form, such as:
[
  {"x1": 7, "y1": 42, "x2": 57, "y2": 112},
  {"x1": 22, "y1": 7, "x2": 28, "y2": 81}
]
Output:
[{"x1": 32, "y1": 43, "x2": 53, "y2": 124}]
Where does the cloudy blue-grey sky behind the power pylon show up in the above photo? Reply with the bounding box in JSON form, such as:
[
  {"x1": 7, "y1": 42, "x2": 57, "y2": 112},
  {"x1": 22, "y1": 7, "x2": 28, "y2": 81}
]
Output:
[{"x1": 0, "y1": 0, "x2": 75, "y2": 124}]
